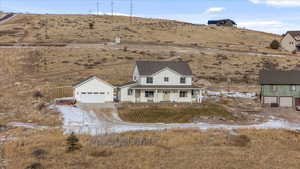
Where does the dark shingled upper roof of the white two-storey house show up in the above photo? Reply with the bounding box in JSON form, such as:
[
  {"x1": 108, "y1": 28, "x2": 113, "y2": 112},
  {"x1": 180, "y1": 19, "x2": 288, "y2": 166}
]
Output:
[{"x1": 136, "y1": 61, "x2": 192, "y2": 76}]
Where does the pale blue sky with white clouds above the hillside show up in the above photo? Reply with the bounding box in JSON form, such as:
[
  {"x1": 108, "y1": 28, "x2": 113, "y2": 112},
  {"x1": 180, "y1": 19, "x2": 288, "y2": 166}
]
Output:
[{"x1": 0, "y1": 0, "x2": 300, "y2": 34}]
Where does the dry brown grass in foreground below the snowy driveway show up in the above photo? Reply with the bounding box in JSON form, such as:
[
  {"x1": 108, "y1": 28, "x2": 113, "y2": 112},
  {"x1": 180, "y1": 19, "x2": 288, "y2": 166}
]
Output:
[{"x1": 4, "y1": 129, "x2": 300, "y2": 169}]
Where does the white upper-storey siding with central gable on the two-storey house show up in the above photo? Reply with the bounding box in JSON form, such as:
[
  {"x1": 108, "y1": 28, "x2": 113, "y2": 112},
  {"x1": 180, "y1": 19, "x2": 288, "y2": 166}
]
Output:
[{"x1": 139, "y1": 69, "x2": 192, "y2": 85}]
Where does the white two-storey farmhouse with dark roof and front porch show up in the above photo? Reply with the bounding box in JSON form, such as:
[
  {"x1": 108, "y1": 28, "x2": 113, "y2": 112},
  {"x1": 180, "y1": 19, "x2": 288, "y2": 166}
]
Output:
[{"x1": 118, "y1": 61, "x2": 204, "y2": 103}]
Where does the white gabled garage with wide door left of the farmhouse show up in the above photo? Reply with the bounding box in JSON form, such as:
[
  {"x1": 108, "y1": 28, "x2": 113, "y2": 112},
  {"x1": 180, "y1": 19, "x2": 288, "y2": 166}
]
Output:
[{"x1": 73, "y1": 76, "x2": 114, "y2": 103}]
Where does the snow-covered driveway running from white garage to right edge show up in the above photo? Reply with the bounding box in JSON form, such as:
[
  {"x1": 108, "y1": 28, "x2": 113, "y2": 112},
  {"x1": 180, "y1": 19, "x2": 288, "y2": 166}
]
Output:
[{"x1": 56, "y1": 106, "x2": 300, "y2": 135}]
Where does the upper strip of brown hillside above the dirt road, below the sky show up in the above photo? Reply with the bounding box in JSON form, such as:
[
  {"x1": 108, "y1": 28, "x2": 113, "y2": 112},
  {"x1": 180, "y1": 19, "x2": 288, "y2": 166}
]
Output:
[{"x1": 0, "y1": 14, "x2": 280, "y2": 48}]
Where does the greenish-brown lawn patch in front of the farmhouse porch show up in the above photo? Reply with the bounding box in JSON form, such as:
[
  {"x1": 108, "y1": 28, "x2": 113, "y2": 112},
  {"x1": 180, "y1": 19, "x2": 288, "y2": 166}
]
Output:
[{"x1": 118, "y1": 102, "x2": 237, "y2": 123}]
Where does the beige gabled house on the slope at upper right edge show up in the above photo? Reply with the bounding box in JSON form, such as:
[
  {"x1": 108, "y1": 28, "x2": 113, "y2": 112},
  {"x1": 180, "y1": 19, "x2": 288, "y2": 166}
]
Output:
[{"x1": 280, "y1": 31, "x2": 300, "y2": 52}]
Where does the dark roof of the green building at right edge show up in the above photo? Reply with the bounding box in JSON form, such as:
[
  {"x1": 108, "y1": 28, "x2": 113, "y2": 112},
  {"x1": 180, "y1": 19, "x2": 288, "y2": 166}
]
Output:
[{"x1": 260, "y1": 70, "x2": 300, "y2": 85}]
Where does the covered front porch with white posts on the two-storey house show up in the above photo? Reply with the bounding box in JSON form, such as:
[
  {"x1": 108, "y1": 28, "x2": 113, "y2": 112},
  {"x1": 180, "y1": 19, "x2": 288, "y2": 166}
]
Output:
[{"x1": 131, "y1": 87, "x2": 203, "y2": 103}]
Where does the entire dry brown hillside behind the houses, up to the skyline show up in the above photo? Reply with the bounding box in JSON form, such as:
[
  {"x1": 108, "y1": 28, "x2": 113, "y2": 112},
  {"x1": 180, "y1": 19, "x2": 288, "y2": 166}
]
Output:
[{"x1": 0, "y1": 14, "x2": 300, "y2": 124}]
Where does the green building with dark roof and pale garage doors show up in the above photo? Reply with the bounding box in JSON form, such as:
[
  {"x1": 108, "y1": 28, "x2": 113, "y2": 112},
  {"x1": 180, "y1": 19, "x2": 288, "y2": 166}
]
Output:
[{"x1": 260, "y1": 71, "x2": 300, "y2": 107}]
